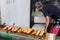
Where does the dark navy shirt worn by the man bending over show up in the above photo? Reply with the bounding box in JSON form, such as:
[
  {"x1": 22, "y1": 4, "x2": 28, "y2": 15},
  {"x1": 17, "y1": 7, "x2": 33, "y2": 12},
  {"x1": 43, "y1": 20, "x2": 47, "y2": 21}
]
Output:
[{"x1": 42, "y1": 4, "x2": 60, "y2": 19}]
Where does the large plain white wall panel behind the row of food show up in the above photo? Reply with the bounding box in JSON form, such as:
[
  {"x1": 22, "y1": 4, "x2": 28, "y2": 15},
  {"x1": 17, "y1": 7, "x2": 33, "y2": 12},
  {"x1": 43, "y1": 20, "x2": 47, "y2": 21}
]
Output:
[{"x1": 1, "y1": 0, "x2": 30, "y2": 27}]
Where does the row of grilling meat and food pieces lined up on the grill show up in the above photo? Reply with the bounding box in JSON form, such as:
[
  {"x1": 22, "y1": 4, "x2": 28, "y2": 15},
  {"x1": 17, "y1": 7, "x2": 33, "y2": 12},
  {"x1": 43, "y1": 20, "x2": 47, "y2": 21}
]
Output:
[{"x1": 3, "y1": 25, "x2": 45, "y2": 36}]
